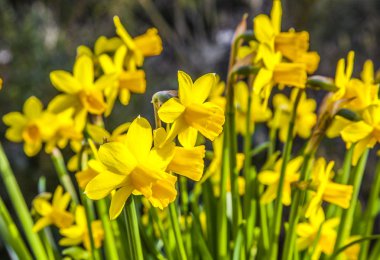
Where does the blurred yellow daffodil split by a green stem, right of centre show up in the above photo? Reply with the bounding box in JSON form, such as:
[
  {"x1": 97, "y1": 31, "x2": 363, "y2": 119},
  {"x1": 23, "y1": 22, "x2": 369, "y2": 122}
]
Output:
[{"x1": 269, "y1": 90, "x2": 317, "y2": 142}]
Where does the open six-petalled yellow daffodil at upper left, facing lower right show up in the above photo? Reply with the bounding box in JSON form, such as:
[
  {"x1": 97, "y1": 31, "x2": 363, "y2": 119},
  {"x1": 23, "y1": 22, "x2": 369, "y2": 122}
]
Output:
[{"x1": 48, "y1": 55, "x2": 115, "y2": 129}]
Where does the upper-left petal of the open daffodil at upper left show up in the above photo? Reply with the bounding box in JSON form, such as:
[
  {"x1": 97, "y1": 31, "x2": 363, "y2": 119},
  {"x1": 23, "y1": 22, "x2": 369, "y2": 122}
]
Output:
[{"x1": 50, "y1": 70, "x2": 82, "y2": 94}]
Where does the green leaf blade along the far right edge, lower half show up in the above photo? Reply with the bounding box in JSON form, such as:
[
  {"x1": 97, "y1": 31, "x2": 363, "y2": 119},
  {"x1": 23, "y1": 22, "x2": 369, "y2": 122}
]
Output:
[{"x1": 359, "y1": 160, "x2": 380, "y2": 259}]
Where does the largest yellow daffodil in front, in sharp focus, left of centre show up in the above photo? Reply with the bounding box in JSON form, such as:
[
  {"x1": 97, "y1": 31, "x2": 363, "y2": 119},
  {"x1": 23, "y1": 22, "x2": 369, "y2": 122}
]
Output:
[{"x1": 85, "y1": 117, "x2": 176, "y2": 219}]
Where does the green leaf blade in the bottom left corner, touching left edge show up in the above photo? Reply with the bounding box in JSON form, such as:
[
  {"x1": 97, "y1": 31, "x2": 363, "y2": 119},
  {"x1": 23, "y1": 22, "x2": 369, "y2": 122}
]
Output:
[{"x1": 0, "y1": 197, "x2": 32, "y2": 260}]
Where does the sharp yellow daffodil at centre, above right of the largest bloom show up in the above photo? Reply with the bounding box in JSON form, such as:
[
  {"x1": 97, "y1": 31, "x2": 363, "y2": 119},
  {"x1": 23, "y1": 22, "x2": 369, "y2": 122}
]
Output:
[{"x1": 158, "y1": 71, "x2": 224, "y2": 147}]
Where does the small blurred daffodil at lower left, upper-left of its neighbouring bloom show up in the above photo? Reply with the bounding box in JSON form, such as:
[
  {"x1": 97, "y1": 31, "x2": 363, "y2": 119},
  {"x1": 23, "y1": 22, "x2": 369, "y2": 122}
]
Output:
[{"x1": 33, "y1": 186, "x2": 74, "y2": 232}]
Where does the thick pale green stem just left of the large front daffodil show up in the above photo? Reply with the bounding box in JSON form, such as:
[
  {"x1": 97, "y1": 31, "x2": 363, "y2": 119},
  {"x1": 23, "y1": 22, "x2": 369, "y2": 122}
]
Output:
[{"x1": 51, "y1": 148, "x2": 79, "y2": 205}]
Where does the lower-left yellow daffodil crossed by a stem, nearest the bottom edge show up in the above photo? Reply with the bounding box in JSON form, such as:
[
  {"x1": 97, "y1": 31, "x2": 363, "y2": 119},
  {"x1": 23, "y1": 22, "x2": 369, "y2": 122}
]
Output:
[{"x1": 59, "y1": 205, "x2": 104, "y2": 252}]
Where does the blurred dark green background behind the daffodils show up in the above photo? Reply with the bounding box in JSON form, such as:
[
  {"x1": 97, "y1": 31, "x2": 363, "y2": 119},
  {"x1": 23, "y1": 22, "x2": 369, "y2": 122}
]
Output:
[{"x1": 0, "y1": 0, "x2": 380, "y2": 258}]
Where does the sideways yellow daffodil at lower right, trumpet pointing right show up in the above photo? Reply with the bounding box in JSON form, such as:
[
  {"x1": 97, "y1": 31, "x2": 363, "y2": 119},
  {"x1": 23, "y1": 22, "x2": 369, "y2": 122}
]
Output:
[{"x1": 305, "y1": 158, "x2": 353, "y2": 218}]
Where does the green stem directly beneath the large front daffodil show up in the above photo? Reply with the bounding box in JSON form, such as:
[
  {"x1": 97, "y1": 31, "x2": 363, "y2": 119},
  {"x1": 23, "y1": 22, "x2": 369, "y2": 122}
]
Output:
[{"x1": 124, "y1": 196, "x2": 144, "y2": 260}]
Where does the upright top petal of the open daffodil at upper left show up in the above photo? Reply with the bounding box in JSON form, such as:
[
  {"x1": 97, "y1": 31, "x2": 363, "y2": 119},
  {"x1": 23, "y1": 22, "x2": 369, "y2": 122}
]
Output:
[{"x1": 73, "y1": 55, "x2": 94, "y2": 88}]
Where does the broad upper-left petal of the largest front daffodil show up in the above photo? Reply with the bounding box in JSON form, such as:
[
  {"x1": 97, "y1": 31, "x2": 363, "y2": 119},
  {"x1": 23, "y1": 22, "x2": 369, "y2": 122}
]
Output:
[{"x1": 98, "y1": 142, "x2": 137, "y2": 177}]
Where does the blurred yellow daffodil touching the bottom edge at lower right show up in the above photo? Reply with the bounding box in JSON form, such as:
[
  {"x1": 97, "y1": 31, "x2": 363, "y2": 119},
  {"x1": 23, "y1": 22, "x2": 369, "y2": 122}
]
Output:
[{"x1": 296, "y1": 208, "x2": 339, "y2": 259}]
